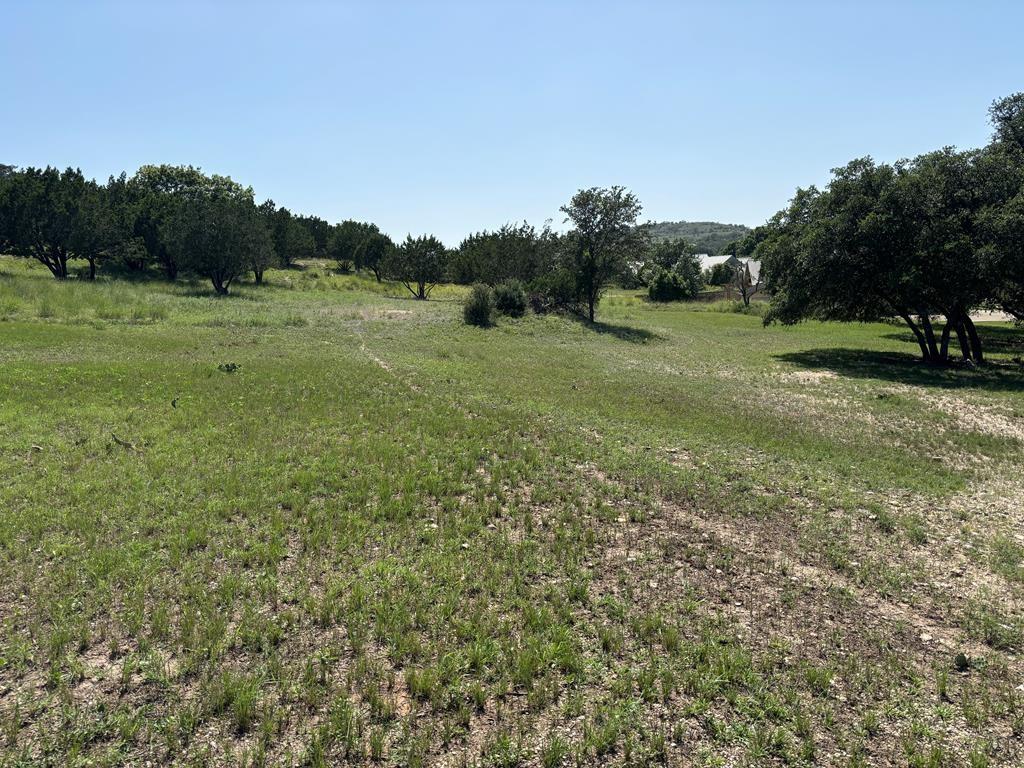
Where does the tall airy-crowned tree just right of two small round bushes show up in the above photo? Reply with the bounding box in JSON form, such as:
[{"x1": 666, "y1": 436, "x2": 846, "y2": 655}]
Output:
[{"x1": 560, "y1": 186, "x2": 647, "y2": 322}]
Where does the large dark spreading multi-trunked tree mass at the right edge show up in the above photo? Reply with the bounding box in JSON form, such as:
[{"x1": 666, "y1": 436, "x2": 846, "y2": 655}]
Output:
[{"x1": 745, "y1": 93, "x2": 1024, "y2": 364}]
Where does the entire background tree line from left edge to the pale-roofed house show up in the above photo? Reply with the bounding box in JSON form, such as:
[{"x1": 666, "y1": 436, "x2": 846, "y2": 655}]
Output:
[{"x1": 0, "y1": 159, "x2": 720, "y2": 321}]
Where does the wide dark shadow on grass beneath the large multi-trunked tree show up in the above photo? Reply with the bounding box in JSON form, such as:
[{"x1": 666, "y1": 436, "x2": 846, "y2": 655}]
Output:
[{"x1": 774, "y1": 350, "x2": 1024, "y2": 392}]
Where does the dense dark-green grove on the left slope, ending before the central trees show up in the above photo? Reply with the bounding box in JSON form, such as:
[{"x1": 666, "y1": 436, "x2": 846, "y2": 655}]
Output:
[{"x1": 0, "y1": 165, "x2": 394, "y2": 294}]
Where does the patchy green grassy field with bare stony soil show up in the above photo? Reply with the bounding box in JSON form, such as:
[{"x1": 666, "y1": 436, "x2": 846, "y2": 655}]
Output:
[{"x1": 0, "y1": 259, "x2": 1024, "y2": 768}]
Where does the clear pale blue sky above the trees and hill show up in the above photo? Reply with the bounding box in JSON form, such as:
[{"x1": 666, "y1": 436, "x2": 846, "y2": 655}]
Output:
[{"x1": 0, "y1": 0, "x2": 1024, "y2": 246}]
